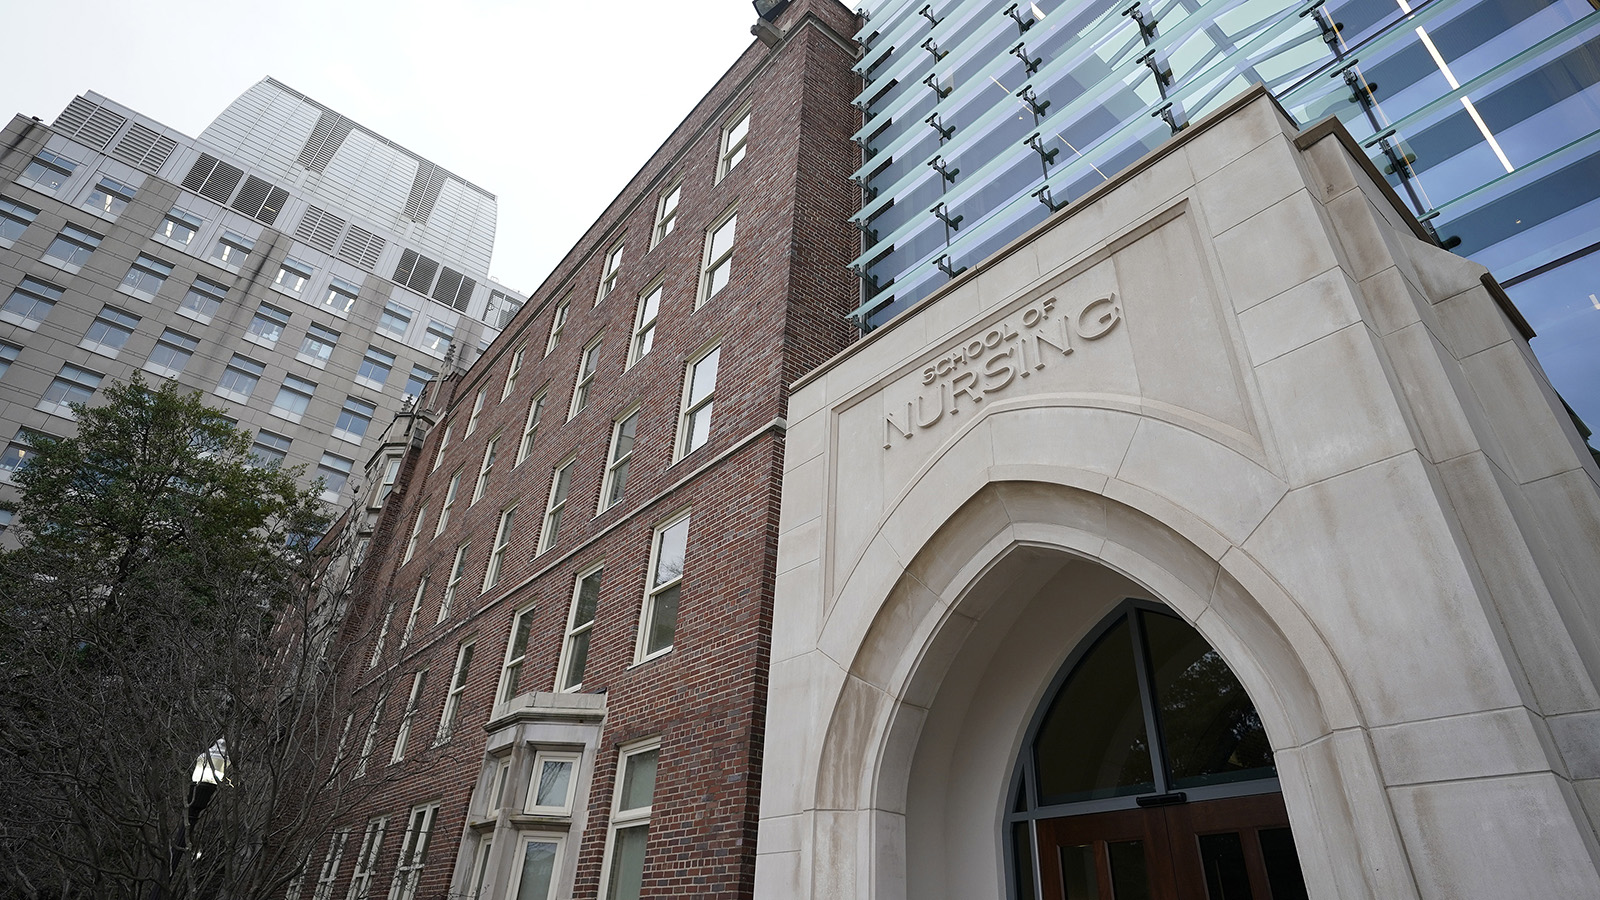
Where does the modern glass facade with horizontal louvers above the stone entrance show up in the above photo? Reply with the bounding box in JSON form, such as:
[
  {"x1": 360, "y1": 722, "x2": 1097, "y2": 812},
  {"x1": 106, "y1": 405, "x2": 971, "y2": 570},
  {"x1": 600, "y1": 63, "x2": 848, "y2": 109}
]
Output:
[{"x1": 856, "y1": 0, "x2": 1600, "y2": 423}]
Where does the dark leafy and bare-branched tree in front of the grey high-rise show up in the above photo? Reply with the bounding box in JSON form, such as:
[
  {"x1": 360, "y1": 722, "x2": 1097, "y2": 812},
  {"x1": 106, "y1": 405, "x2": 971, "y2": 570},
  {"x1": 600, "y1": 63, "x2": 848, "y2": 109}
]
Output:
[{"x1": 0, "y1": 376, "x2": 396, "y2": 900}]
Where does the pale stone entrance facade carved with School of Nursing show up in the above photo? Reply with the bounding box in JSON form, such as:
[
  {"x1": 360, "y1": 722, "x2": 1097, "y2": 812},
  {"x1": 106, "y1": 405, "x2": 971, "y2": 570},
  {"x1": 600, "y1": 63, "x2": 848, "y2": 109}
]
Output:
[{"x1": 755, "y1": 88, "x2": 1600, "y2": 900}]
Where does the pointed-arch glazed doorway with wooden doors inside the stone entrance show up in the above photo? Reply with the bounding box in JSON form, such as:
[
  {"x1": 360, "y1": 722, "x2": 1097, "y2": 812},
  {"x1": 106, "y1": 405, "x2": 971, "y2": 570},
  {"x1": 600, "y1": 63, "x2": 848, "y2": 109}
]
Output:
[{"x1": 1005, "y1": 601, "x2": 1307, "y2": 900}]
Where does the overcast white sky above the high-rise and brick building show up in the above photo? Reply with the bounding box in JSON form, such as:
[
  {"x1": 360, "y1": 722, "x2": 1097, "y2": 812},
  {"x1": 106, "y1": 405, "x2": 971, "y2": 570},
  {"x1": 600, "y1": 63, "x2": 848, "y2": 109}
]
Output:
[{"x1": 0, "y1": 0, "x2": 755, "y2": 293}]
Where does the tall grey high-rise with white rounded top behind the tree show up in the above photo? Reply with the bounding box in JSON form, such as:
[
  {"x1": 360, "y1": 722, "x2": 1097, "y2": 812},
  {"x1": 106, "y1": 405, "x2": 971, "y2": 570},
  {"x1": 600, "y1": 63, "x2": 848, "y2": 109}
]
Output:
[{"x1": 0, "y1": 78, "x2": 525, "y2": 522}]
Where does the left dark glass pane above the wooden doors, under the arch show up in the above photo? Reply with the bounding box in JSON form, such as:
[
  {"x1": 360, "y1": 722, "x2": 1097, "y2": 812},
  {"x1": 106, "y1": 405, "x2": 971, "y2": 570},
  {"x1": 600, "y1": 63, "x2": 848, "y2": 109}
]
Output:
[{"x1": 1034, "y1": 618, "x2": 1155, "y2": 806}]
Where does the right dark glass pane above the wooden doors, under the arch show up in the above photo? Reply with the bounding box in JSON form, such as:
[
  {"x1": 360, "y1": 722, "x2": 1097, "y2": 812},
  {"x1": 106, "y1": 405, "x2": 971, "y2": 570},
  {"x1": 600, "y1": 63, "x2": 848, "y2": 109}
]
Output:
[{"x1": 1141, "y1": 613, "x2": 1277, "y2": 790}]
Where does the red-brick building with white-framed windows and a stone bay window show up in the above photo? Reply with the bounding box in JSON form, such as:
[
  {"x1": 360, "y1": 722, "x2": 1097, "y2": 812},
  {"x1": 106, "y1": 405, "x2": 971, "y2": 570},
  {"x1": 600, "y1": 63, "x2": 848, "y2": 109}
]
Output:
[{"x1": 310, "y1": 0, "x2": 861, "y2": 900}]
